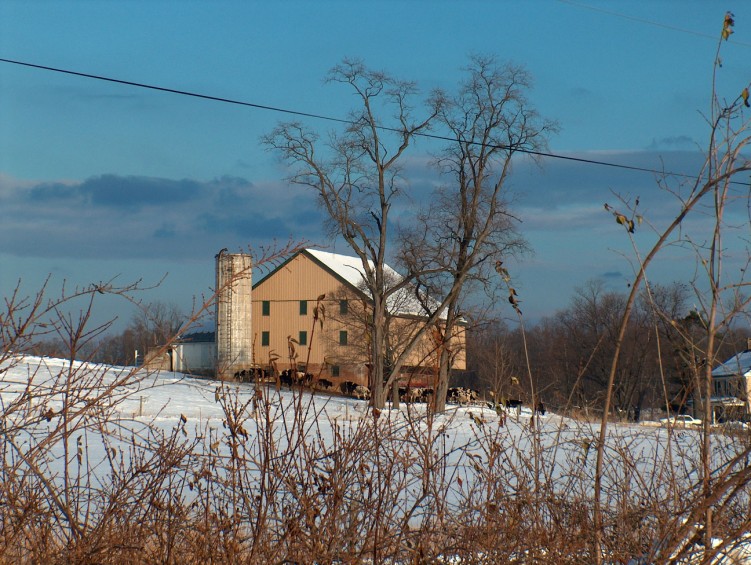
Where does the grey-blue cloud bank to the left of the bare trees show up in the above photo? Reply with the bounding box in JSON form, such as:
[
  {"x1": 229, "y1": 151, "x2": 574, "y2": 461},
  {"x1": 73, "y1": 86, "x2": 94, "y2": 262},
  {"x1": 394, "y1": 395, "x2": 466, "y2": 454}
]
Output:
[{"x1": 0, "y1": 174, "x2": 320, "y2": 259}]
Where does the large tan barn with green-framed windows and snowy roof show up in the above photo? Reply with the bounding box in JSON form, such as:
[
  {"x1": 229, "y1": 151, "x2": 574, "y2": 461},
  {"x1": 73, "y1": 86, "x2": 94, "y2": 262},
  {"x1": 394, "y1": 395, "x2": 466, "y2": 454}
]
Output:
[{"x1": 252, "y1": 249, "x2": 466, "y2": 386}]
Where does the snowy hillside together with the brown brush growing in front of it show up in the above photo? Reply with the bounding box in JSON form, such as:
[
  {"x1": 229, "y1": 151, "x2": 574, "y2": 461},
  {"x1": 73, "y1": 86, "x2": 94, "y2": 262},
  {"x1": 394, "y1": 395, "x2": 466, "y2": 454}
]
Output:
[{"x1": 0, "y1": 356, "x2": 749, "y2": 563}]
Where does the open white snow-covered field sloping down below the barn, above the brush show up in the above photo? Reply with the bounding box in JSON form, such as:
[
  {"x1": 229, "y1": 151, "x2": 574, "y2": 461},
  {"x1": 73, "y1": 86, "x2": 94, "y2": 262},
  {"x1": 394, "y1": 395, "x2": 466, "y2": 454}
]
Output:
[{"x1": 0, "y1": 356, "x2": 751, "y2": 563}]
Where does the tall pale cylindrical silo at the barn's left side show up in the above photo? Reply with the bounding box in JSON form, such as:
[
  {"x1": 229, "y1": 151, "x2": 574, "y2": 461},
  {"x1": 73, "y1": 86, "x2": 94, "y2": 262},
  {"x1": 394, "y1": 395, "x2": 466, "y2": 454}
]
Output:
[{"x1": 216, "y1": 249, "x2": 253, "y2": 379}]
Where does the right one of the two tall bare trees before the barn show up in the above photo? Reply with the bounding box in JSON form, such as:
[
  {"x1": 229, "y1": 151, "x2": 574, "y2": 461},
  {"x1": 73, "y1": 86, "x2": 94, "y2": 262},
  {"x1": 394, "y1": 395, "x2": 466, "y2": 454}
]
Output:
[{"x1": 401, "y1": 56, "x2": 557, "y2": 410}]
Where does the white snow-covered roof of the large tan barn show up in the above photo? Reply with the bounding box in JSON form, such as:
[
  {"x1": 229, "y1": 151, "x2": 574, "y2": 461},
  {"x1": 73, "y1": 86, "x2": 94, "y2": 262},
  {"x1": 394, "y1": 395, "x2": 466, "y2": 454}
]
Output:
[{"x1": 305, "y1": 249, "x2": 446, "y2": 319}]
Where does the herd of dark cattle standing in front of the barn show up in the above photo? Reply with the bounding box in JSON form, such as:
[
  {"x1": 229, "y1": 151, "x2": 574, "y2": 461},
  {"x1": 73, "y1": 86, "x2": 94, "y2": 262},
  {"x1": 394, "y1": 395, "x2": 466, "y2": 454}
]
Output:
[{"x1": 235, "y1": 368, "x2": 506, "y2": 407}]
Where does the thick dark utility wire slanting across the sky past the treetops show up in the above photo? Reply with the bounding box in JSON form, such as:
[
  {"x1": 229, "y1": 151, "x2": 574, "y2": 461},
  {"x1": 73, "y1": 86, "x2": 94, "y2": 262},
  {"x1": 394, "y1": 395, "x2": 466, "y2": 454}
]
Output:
[{"x1": 0, "y1": 58, "x2": 736, "y2": 185}]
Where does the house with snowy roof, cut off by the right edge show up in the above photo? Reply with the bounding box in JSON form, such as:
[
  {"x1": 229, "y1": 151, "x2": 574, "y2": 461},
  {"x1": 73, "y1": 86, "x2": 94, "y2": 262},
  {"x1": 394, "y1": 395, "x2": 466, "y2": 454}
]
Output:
[{"x1": 712, "y1": 344, "x2": 751, "y2": 421}]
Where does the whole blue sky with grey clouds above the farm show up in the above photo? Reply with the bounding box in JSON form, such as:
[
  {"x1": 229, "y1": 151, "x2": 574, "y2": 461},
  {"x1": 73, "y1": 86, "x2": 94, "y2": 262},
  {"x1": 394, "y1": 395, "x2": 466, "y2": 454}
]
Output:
[{"x1": 0, "y1": 0, "x2": 751, "y2": 327}]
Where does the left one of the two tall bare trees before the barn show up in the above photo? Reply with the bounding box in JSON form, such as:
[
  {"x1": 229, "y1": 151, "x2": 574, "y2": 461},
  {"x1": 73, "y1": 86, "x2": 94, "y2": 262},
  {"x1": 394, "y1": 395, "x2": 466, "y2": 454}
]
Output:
[{"x1": 263, "y1": 59, "x2": 443, "y2": 408}]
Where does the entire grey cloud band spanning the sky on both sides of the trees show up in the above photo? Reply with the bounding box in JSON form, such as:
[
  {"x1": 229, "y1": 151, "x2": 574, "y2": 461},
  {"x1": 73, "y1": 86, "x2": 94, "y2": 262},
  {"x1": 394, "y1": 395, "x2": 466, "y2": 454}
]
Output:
[{"x1": 0, "y1": 145, "x2": 747, "y2": 324}]
